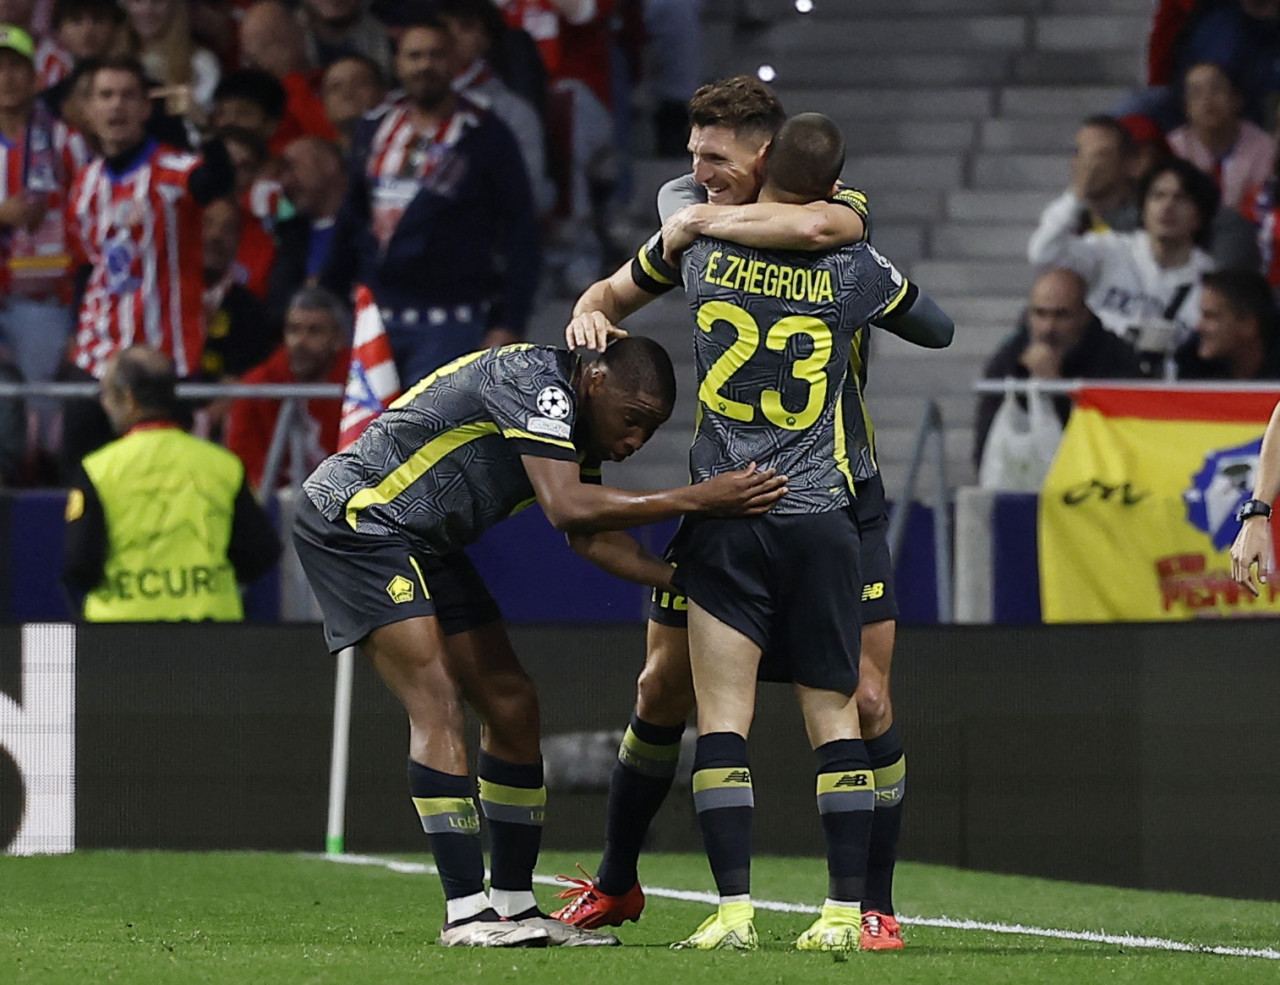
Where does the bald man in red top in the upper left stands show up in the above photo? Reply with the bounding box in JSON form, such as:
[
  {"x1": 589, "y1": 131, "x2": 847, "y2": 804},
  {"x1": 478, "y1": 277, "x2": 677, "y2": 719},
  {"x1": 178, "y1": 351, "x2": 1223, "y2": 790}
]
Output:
[{"x1": 241, "y1": 0, "x2": 338, "y2": 155}]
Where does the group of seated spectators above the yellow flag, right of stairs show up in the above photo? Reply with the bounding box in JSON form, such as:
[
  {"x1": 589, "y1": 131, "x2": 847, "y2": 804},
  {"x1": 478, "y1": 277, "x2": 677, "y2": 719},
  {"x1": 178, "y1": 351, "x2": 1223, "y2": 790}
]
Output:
[{"x1": 973, "y1": 0, "x2": 1280, "y2": 475}]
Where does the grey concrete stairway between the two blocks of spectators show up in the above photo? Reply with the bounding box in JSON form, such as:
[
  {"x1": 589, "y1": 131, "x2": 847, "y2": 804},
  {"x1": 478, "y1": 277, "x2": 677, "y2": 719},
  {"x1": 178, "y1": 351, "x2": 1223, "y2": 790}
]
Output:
[{"x1": 534, "y1": 0, "x2": 1151, "y2": 495}]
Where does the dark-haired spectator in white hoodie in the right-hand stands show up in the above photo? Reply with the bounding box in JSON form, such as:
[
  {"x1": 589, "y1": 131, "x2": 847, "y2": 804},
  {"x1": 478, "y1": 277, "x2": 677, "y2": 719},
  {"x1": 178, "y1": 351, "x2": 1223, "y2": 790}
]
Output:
[{"x1": 1027, "y1": 159, "x2": 1217, "y2": 353}]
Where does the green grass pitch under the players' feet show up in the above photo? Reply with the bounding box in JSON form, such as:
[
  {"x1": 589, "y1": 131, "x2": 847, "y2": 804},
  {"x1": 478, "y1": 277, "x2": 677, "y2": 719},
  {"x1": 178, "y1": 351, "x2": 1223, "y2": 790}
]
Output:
[{"x1": 0, "y1": 852, "x2": 1280, "y2": 985}]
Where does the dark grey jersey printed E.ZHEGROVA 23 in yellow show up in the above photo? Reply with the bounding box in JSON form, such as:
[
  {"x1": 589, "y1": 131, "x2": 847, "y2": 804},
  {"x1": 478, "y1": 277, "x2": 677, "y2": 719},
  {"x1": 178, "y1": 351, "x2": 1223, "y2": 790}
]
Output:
[{"x1": 681, "y1": 239, "x2": 908, "y2": 513}]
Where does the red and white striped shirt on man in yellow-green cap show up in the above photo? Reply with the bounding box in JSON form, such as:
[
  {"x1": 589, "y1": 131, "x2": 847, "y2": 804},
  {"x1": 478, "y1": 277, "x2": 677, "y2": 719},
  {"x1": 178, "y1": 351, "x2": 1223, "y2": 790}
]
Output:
[{"x1": 0, "y1": 110, "x2": 91, "y2": 303}]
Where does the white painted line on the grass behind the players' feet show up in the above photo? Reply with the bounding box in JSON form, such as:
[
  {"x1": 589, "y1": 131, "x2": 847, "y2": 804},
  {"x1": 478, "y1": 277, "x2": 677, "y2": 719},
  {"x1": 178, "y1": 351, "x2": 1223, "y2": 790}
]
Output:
[{"x1": 307, "y1": 855, "x2": 1280, "y2": 961}]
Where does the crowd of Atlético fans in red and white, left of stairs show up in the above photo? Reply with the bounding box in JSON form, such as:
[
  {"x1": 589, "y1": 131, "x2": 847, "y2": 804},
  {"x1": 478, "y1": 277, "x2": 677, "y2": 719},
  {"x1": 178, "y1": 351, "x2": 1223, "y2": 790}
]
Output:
[{"x1": 0, "y1": 0, "x2": 699, "y2": 486}]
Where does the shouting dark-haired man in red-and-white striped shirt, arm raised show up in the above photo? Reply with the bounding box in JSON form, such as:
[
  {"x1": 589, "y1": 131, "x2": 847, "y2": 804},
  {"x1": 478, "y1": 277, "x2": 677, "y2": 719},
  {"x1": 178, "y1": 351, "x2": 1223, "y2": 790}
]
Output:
[{"x1": 63, "y1": 58, "x2": 236, "y2": 468}]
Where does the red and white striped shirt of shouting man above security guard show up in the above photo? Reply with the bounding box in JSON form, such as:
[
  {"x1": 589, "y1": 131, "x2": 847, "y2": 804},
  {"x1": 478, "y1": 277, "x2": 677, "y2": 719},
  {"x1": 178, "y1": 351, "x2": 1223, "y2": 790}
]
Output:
[{"x1": 68, "y1": 139, "x2": 205, "y2": 379}]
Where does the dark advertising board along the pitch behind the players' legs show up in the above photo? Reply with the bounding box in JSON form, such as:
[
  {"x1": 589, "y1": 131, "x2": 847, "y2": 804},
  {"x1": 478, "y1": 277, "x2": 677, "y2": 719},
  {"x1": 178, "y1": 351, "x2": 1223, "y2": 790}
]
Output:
[{"x1": 0, "y1": 620, "x2": 1280, "y2": 899}]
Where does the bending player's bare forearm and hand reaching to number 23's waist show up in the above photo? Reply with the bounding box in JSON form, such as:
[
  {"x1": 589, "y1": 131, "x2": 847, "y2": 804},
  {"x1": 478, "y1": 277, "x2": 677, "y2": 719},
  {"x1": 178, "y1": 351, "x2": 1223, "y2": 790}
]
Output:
[{"x1": 521, "y1": 454, "x2": 787, "y2": 535}]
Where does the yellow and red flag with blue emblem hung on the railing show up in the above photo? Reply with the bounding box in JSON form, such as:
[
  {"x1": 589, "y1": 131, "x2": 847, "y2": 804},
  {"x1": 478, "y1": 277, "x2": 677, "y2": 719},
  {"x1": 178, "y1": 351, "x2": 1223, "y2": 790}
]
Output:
[{"x1": 1039, "y1": 388, "x2": 1280, "y2": 623}]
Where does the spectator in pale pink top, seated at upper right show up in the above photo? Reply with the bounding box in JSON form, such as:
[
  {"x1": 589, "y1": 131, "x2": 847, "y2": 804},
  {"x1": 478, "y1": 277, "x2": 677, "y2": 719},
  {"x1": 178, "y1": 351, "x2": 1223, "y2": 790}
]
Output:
[{"x1": 1169, "y1": 61, "x2": 1276, "y2": 209}]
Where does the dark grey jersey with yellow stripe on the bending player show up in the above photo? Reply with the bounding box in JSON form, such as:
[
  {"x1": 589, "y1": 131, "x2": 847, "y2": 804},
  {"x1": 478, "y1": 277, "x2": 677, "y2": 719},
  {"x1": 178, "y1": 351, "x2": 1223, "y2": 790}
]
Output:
[{"x1": 303, "y1": 344, "x2": 599, "y2": 554}]
